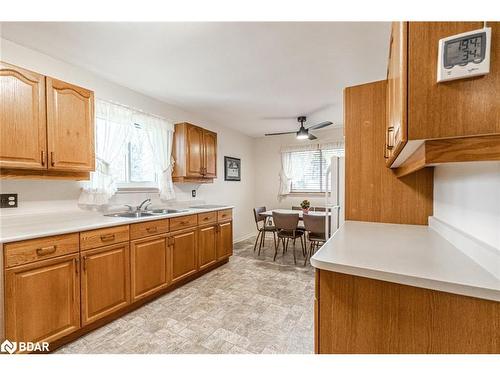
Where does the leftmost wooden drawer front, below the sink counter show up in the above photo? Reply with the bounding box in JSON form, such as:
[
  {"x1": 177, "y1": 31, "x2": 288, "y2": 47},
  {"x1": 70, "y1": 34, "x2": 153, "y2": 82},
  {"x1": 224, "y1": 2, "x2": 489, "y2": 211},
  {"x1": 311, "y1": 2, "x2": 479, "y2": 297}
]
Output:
[{"x1": 4, "y1": 233, "x2": 79, "y2": 268}]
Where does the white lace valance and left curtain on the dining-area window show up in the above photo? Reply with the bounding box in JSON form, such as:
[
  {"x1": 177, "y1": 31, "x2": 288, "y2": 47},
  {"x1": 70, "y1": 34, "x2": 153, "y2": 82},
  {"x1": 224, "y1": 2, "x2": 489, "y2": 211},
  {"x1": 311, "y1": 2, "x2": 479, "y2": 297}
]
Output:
[{"x1": 278, "y1": 141, "x2": 344, "y2": 198}]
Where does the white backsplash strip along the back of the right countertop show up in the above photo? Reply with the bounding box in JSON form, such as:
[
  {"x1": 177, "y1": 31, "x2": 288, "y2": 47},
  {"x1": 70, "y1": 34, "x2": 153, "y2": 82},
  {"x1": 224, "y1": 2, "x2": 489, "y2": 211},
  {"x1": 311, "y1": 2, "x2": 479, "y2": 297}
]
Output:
[{"x1": 429, "y1": 216, "x2": 500, "y2": 279}]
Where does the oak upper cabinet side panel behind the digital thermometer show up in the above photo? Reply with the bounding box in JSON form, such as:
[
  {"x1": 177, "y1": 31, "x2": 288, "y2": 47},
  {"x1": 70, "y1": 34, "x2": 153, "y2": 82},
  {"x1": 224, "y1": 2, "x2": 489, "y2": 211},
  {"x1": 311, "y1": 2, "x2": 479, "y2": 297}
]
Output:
[{"x1": 408, "y1": 21, "x2": 500, "y2": 140}]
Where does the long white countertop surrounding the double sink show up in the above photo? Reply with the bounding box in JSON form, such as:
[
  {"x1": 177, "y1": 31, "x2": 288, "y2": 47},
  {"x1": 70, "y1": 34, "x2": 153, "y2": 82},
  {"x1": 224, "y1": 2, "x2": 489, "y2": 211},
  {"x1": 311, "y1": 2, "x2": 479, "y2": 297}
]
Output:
[{"x1": 0, "y1": 205, "x2": 234, "y2": 243}]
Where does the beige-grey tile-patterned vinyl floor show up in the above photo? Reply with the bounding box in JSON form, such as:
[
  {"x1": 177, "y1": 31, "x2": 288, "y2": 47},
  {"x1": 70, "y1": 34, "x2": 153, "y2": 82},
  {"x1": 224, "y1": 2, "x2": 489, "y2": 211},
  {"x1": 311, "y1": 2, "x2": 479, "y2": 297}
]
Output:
[{"x1": 56, "y1": 236, "x2": 314, "y2": 354}]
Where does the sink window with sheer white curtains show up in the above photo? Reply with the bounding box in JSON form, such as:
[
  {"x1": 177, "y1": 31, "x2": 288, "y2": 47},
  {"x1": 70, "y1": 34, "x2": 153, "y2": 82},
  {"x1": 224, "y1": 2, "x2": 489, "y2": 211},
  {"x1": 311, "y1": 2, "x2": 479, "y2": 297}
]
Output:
[{"x1": 78, "y1": 99, "x2": 175, "y2": 206}]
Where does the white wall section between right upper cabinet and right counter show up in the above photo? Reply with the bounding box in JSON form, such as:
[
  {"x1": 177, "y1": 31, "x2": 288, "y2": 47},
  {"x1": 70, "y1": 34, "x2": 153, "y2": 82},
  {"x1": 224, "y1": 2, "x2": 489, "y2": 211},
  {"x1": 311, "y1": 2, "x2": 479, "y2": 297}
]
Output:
[{"x1": 434, "y1": 162, "x2": 500, "y2": 250}]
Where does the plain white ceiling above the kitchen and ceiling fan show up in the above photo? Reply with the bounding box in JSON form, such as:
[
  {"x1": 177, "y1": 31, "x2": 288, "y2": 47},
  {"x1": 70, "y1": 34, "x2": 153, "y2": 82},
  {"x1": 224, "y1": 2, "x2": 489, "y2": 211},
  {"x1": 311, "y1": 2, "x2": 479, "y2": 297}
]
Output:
[{"x1": 2, "y1": 22, "x2": 390, "y2": 136}]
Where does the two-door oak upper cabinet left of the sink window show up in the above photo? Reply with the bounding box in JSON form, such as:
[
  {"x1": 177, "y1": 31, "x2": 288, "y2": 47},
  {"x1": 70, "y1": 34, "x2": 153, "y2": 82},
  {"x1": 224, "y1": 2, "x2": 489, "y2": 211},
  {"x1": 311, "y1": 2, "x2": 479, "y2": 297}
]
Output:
[{"x1": 0, "y1": 62, "x2": 95, "y2": 180}]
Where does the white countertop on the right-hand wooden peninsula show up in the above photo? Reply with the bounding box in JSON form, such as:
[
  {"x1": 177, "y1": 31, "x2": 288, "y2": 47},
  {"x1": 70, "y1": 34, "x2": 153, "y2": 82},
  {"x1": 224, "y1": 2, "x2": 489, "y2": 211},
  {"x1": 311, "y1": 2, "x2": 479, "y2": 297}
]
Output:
[{"x1": 311, "y1": 221, "x2": 500, "y2": 301}]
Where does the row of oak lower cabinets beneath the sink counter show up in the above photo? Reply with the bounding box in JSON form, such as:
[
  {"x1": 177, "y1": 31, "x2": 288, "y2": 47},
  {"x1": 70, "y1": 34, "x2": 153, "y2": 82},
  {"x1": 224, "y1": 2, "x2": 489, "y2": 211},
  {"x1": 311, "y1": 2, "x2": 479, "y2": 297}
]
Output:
[{"x1": 0, "y1": 210, "x2": 233, "y2": 350}]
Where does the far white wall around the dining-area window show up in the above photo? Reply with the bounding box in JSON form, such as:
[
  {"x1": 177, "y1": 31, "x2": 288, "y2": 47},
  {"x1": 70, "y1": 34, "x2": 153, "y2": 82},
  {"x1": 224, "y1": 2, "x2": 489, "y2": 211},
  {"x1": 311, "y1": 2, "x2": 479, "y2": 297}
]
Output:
[{"x1": 255, "y1": 128, "x2": 344, "y2": 212}]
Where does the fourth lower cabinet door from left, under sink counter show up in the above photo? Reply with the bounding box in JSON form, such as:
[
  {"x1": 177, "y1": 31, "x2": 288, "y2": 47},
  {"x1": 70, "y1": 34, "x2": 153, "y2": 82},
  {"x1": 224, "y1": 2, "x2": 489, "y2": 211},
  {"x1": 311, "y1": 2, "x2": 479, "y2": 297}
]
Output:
[{"x1": 169, "y1": 229, "x2": 198, "y2": 282}]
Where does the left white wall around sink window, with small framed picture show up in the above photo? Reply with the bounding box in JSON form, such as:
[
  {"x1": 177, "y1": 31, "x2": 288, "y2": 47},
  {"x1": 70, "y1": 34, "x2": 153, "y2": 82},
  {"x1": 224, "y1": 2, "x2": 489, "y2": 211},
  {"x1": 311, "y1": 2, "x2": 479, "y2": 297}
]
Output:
[{"x1": 0, "y1": 39, "x2": 255, "y2": 239}]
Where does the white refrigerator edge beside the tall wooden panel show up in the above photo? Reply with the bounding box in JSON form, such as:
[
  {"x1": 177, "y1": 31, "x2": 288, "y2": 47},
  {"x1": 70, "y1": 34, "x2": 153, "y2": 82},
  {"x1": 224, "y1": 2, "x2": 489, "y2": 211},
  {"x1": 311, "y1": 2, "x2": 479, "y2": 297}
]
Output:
[{"x1": 325, "y1": 156, "x2": 345, "y2": 238}]
